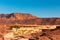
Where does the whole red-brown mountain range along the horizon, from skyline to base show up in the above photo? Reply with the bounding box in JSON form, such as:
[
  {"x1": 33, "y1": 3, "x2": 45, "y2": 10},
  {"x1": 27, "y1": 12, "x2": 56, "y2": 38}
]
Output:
[{"x1": 0, "y1": 13, "x2": 60, "y2": 25}]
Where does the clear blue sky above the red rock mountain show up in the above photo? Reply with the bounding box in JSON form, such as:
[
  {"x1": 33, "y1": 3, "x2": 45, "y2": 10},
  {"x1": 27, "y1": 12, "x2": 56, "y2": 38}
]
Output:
[{"x1": 0, "y1": 0, "x2": 60, "y2": 17}]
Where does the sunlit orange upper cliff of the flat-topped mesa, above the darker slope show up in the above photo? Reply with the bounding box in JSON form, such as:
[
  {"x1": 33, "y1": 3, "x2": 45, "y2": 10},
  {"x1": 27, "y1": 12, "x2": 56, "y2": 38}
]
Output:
[{"x1": 0, "y1": 13, "x2": 37, "y2": 20}]
